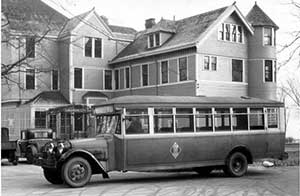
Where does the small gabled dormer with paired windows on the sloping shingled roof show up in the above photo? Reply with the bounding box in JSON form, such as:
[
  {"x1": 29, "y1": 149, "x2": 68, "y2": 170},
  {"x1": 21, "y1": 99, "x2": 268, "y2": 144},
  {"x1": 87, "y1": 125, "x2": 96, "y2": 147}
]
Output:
[{"x1": 145, "y1": 18, "x2": 176, "y2": 49}]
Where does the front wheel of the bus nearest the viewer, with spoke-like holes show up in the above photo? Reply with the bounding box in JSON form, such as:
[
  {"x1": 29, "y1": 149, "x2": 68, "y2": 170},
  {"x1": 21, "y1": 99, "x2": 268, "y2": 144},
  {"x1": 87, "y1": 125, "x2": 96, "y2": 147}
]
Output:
[{"x1": 62, "y1": 157, "x2": 92, "y2": 188}]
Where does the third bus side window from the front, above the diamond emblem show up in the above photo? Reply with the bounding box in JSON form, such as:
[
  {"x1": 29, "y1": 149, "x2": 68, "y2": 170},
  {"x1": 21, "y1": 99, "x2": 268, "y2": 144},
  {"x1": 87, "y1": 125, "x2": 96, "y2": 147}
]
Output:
[{"x1": 175, "y1": 108, "x2": 194, "y2": 132}]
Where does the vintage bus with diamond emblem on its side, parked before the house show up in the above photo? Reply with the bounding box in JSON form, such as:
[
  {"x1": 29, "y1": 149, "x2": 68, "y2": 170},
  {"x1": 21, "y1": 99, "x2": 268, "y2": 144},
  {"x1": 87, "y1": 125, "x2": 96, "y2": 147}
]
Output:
[{"x1": 41, "y1": 96, "x2": 286, "y2": 187}]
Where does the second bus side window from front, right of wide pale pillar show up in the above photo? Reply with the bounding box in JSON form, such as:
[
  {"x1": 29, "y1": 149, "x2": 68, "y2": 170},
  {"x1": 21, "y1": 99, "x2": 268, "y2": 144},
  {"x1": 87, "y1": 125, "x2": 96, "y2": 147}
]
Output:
[{"x1": 154, "y1": 108, "x2": 174, "y2": 133}]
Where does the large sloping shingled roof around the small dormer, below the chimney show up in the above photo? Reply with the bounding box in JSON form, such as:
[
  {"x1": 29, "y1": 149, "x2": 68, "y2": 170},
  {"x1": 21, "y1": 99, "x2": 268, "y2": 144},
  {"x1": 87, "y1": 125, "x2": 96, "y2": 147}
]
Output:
[{"x1": 111, "y1": 7, "x2": 228, "y2": 64}]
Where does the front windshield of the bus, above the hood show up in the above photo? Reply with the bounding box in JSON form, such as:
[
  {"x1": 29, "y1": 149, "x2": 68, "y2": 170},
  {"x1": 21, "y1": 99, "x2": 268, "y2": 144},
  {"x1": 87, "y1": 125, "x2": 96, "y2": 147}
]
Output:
[{"x1": 97, "y1": 115, "x2": 121, "y2": 134}]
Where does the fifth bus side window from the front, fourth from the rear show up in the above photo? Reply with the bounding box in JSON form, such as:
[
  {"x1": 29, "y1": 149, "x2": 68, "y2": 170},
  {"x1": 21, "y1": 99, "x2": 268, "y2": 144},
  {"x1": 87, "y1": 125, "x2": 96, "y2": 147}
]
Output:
[{"x1": 215, "y1": 108, "x2": 231, "y2": 131}]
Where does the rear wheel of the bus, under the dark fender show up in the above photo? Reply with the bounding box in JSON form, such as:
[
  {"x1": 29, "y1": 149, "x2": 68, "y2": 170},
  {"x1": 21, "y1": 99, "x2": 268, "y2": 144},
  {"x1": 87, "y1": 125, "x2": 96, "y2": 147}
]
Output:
[{"x1": 223, "y1": 152, "x2": 248, "y2": 177}]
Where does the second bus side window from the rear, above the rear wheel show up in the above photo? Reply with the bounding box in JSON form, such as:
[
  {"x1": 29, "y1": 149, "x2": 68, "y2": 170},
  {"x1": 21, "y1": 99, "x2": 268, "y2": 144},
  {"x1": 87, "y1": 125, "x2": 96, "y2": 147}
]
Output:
[{"x1": 250, "y1": 108, "x2": 265, "y2": 130}]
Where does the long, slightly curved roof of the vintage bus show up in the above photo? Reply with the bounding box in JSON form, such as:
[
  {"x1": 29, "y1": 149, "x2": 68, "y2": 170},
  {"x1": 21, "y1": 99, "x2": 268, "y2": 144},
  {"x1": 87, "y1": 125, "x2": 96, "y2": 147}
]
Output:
[{"x1": 93, "y1": 95, "x2": 284, "y2": 108}]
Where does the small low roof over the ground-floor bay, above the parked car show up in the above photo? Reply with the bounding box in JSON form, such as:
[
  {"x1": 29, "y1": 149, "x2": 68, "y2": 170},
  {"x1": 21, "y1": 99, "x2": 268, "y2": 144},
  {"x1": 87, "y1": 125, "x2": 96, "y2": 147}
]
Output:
[{"x1": 25, "y1": 91, "x2": 70, "y2": 105}]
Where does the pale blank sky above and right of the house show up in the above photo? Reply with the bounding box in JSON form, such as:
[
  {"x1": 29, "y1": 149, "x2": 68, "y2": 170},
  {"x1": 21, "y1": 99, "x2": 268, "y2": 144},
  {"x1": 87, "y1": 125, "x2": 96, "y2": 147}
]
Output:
[{"x1": 43, "y1": 0, "x2": 300, "y2": 139}]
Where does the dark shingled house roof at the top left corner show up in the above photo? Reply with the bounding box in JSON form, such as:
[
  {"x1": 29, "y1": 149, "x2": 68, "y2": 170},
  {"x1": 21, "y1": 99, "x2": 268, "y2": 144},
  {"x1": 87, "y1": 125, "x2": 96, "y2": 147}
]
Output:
[{"x1": 1, "y1": 0, "x2": 68, "y2": 36}]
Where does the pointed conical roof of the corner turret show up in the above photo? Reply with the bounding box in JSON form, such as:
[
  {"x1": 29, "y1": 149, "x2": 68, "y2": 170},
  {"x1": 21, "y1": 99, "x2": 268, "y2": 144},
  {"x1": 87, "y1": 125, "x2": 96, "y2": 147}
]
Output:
[{"x1": 246, "y1": 3, "x2": 279, "y2": 29}]
